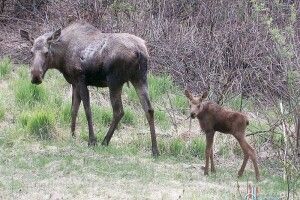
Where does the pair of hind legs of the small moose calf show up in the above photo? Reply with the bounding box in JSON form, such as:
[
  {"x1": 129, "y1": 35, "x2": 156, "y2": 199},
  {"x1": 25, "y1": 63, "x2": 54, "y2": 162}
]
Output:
[{"x1": 236, "y1": 136, "x2": 260, "y2": 181}]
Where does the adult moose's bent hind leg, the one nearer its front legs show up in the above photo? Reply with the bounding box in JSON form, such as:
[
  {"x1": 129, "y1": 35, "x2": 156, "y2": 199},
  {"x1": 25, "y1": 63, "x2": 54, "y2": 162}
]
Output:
[{"x1": 102, "y1": 86, "x2": 124, "y2": 145}]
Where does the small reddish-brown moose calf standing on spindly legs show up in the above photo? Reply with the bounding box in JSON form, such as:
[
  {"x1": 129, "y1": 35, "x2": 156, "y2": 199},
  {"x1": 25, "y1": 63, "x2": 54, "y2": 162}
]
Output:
[{"x1": 185, "y1": 90, "x2": 259, "y2": 180}]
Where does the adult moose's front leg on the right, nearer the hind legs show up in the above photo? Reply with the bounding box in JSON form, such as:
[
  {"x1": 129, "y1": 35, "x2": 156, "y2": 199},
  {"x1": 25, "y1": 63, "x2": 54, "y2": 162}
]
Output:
[{"x1": 79, "y1": 83, "x2": 97, "y2": 146}]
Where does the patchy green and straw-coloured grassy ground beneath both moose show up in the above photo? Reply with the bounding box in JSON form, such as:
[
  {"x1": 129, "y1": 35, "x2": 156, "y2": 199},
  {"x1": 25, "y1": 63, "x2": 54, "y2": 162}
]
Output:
[{"x1": 0, "y1": 59, "x2": 297, "y2": 199}]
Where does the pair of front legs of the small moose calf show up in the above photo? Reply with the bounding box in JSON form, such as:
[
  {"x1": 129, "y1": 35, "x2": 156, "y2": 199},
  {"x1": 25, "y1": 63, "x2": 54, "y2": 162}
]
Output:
[{"x1": 204, "y1": 132, "x2": 215, "y2": 175}]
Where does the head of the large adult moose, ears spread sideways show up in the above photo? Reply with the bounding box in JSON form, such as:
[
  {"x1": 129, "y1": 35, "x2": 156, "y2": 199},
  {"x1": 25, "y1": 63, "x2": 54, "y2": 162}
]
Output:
[{"x1": 20, "y1": 29, "x2": 61, "y2": 84}]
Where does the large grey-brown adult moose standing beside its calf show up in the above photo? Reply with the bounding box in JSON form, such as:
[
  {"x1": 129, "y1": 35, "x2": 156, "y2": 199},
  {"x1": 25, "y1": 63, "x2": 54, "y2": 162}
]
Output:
[{"x1": 20, "y1": 22, "x2": 159, "y2": 156}]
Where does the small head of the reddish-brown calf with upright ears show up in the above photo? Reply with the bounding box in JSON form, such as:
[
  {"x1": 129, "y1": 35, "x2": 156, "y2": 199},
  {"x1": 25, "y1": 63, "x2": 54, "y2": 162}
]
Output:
[{"x1": 184, "y1": 89, "x2": 208, "y2": 119}]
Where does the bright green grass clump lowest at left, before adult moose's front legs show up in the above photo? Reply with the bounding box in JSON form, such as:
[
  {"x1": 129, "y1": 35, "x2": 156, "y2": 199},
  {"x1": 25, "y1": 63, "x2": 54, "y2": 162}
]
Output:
[{"x1": 20, "y1": 108, "x2": 55, "y2": 139}]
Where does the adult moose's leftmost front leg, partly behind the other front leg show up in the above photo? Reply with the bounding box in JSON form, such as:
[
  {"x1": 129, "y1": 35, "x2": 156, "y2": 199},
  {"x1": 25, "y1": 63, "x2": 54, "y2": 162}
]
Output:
[{"x1": 71, "y1": 85, "x2": 81, "y2": 137}]
